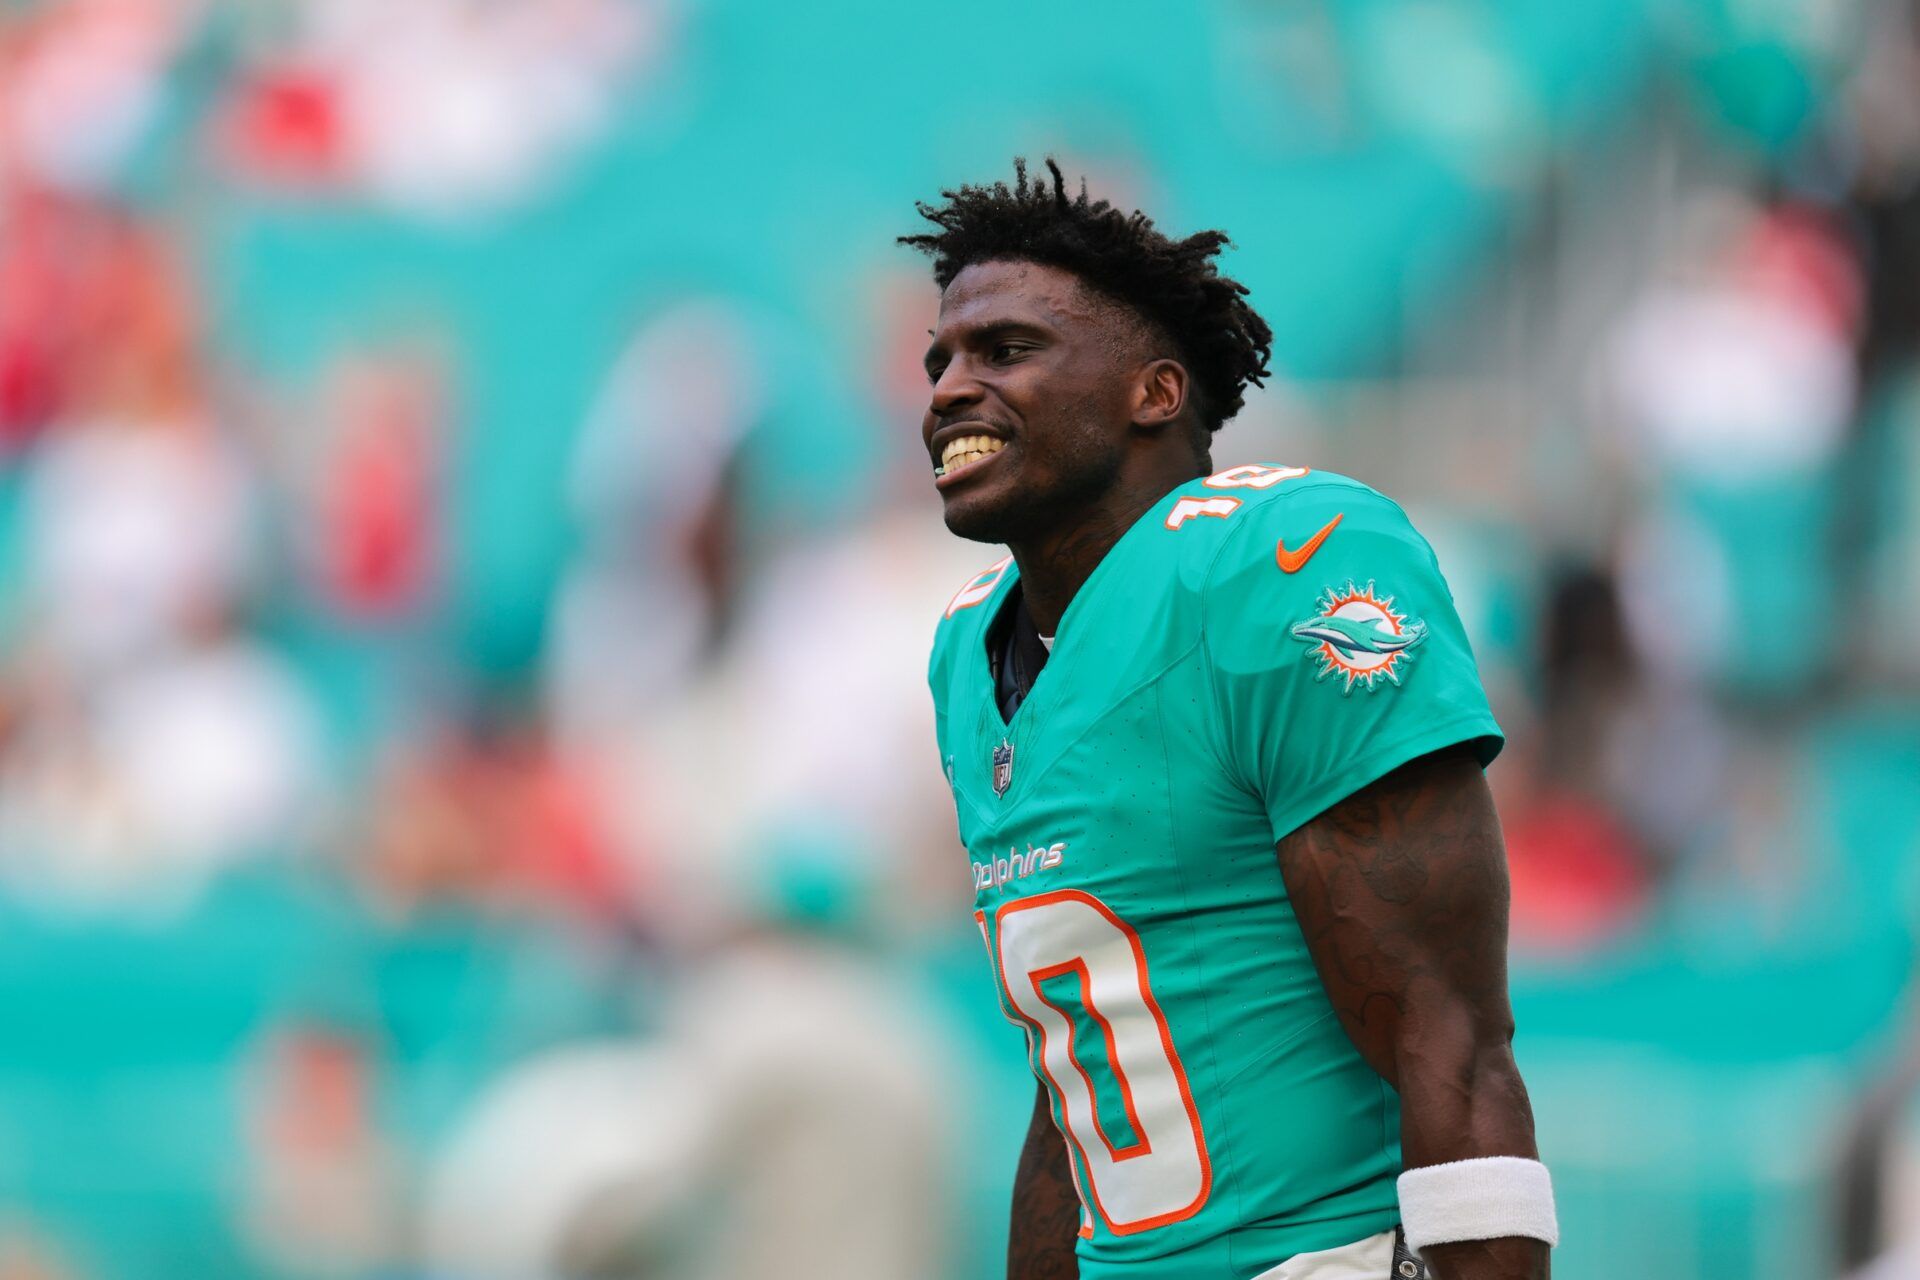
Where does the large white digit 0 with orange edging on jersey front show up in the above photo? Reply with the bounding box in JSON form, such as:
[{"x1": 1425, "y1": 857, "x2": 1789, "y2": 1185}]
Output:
[{"x1": 979, "y1": 889, "x2": 1213, "y2": 1236}]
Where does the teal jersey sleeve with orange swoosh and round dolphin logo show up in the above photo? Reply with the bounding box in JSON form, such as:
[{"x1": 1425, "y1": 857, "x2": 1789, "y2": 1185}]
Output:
[{"x1": 1200, "y1": 484, "x2": 1503, "y2": 839}]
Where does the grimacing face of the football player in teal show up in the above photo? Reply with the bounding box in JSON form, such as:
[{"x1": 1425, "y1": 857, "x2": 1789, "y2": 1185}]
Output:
[{"x1": 920, "y1": 261, "x2": 1137, "y2": 543}]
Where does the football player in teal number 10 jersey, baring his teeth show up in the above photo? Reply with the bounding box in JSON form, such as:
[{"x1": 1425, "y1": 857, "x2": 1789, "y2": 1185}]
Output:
[{"x1": 902, "y1": 161, "x2": 1557, "y2": 1280}]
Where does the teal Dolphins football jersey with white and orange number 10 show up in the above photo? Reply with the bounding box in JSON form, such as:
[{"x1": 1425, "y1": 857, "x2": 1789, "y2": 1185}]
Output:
[{"x1": 929, "y1": 466, "x2": 1501, "y2": 1280}]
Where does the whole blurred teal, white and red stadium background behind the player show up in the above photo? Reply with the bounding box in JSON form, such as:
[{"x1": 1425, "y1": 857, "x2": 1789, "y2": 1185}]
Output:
[{"x1": 0, "y1": 0, "x2": 1920, "y2": 1280}]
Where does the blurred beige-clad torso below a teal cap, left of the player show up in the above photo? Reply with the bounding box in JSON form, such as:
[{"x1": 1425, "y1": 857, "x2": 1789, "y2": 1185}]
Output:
[{"x1": 674, "y1": 917, "x2": 958, "y2": 1280}]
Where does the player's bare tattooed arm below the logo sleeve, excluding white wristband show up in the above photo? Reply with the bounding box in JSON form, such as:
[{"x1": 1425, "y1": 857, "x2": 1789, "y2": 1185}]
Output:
[{"x1": 1279, "y1": 747, "x2": 1548, "y2": 1280}]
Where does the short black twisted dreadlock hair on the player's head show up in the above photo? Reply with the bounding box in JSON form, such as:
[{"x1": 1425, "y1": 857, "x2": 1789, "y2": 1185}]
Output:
[{"x1": 900, "y1": 159, "x2": 1273, "y2": 432}]
